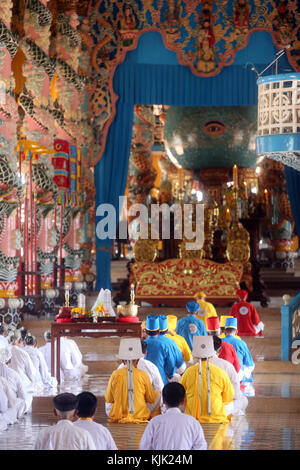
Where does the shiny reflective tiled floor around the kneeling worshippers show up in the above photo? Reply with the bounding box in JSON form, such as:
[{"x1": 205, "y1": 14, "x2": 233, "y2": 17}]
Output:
[{"x1": 0, "y1": 301, "x2": 300, "y2": 450}]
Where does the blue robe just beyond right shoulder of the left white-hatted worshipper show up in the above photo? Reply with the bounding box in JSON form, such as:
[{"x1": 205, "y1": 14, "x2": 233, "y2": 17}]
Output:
[{"x1": 145, "y1": 336, "x2": 176, "y2": 385}]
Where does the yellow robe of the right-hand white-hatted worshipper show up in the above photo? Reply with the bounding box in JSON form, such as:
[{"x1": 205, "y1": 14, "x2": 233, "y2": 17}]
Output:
[{"x1": 180, "y1": 361, "x2": 234, "y2": 423}]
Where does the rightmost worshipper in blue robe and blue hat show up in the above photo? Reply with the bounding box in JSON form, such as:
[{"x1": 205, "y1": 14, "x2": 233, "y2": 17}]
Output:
[{"x1": 222, "y1": 317, "x2": 255, "y2": 383}]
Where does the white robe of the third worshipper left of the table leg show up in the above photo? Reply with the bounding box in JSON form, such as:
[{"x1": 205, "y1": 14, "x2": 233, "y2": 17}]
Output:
[{"x1": 0, "y1": 364, "x2": 32, "y2": 418}]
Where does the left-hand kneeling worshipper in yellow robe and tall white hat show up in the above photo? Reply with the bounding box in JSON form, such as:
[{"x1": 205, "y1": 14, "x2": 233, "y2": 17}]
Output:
[{"x1": 105, "y1": 338, "x2": 161, "y2": 423}]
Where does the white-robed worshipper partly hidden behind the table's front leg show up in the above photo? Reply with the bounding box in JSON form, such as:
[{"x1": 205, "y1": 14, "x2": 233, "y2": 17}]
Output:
[{"x1": 38, "y1": 330, "x2": 82, "y2": 381}]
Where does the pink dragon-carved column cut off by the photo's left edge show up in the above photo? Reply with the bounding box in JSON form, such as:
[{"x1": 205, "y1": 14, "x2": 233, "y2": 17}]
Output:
[{"x1": 0, "y1": 1, "x2": 22, "y2": 297}]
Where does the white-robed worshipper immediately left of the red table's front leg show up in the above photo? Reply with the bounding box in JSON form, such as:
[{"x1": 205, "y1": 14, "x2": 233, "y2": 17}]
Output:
[{"x1": 24, "y1": 333, "x2": 57, "y2": 388}]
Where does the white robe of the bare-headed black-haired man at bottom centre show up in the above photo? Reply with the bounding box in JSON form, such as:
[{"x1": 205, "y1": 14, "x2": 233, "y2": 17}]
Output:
[{"x1": 139, "y1": 408, "x2": 207, "y2": 451}]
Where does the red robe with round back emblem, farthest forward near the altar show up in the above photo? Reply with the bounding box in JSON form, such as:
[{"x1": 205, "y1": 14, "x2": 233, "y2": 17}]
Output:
[{"x1": 230, "y1": 300, "x2": 260, "y2": 336}]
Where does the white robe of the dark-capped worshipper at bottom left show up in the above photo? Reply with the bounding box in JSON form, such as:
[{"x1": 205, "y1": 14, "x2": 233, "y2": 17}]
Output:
[{"x1": 34, "y1": 419, "x2": 96, "y2": 450}]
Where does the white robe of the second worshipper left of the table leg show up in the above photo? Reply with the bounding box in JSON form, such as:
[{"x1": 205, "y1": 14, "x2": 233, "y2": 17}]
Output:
[{"x1": 10, "y1": 346, "x2": 36, "y2": 391}]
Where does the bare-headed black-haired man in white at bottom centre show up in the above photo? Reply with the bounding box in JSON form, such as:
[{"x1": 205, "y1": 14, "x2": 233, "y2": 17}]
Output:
[{"x1": 139, "y1": 382, "x2": 207, "y2": 450}]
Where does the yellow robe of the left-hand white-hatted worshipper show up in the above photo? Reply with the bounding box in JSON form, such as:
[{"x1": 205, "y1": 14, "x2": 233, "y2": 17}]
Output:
[{"x1": 105, "y1": 367, "x2": 159, "y2": 423}]
